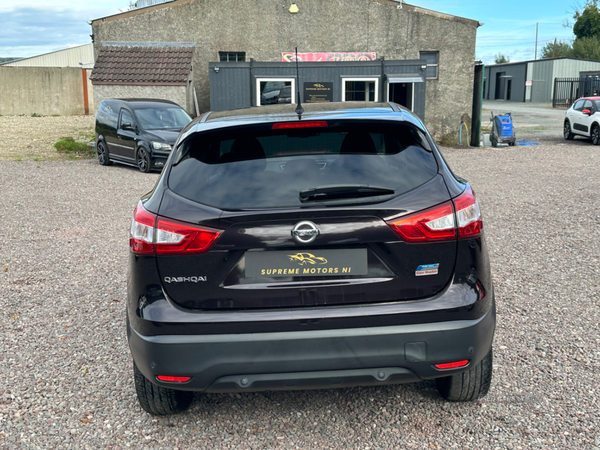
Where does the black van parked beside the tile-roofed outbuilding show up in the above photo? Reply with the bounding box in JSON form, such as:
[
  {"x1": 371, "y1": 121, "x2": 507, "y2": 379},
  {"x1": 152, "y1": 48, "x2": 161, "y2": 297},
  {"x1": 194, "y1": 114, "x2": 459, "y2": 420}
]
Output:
[{"x1": 96, "y1": 99, "x2": 192, "y2": 172}]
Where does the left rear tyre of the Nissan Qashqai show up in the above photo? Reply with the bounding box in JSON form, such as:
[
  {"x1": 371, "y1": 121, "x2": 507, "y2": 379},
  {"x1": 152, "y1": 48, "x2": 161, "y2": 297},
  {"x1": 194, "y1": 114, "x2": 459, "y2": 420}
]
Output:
[{"x1": 133, "y1": 363, "x2": 194, "y2": 416}]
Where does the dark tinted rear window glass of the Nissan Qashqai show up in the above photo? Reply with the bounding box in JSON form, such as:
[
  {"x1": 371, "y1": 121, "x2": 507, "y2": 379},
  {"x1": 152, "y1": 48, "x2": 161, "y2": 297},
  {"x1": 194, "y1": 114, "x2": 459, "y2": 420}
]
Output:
[{"x1": 169, "y1": 122, "x2": 438, "y2": 210}]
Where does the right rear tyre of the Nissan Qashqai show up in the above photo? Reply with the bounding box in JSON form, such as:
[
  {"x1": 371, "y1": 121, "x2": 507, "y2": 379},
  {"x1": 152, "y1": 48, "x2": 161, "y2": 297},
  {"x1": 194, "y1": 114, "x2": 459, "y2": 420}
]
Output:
[{"x1": 435, "y1": 349, "x2": 494, "y2": 402}]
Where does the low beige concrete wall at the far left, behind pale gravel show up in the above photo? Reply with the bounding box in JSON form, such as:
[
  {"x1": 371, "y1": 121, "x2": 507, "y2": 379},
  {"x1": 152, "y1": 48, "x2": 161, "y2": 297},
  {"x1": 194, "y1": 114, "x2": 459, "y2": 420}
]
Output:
[{"x1": 0, "y1": 66, "x2": 92, "y2": 116}]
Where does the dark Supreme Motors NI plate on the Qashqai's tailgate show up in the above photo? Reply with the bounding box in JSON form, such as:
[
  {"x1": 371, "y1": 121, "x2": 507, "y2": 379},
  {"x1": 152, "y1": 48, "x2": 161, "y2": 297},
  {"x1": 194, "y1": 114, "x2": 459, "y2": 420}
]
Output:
[{"x1": 244, "y1": 248, "x2": 367, "y2": 278}]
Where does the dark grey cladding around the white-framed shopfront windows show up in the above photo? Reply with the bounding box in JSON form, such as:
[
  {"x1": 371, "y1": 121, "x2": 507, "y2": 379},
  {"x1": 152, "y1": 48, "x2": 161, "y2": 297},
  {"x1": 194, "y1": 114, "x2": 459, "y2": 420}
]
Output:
[{"x1": 209, "y1": 60, "x2": 426, "y2": 120}]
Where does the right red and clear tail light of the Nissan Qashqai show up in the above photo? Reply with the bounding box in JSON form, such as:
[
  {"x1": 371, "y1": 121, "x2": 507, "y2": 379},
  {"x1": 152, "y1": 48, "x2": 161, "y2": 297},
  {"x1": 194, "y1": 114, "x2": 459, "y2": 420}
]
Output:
[{"x1": 388, "y1": 185, "x2": 483, "y2": 242}]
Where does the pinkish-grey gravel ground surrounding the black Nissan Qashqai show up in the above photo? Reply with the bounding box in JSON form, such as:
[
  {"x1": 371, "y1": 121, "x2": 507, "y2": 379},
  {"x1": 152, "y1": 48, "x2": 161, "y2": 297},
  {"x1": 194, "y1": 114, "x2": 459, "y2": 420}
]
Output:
[{"x1": 0, "y1": 133, "x2": 600, "y2": 449}]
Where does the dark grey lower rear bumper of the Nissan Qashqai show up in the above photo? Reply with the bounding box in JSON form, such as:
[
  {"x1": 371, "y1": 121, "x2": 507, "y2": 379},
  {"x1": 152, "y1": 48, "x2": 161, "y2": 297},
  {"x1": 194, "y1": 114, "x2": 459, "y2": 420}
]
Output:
[{"x1": 128, "y1": 302, "x2": 496, "y2": 392}]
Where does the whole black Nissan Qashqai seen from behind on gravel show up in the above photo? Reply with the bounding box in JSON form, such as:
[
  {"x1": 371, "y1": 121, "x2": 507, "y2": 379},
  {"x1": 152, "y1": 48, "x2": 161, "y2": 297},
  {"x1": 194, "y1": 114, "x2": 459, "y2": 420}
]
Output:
[{"x1": 127, "y1": 102, "x2": 495, "y2": 415}]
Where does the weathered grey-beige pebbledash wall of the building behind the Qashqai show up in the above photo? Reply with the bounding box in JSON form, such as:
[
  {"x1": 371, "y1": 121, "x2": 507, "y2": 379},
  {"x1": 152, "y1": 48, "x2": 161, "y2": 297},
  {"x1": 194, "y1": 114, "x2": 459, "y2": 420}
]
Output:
[{"x1": 92, "y1": 0, "x2": 480, "y2": 139}]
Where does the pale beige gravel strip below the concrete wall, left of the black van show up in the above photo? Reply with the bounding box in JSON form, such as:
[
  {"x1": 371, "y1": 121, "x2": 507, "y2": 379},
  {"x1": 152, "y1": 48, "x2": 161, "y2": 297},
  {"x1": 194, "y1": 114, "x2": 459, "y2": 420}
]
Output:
[{"x1": 0, "y1": 115, "x2": 95, "y2": 161}]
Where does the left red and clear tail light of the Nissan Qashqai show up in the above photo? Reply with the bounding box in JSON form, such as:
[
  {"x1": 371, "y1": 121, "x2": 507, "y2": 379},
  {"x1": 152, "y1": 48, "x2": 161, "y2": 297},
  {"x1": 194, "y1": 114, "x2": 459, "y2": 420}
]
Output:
[{"x1": 129, "y1": 202, "x2": 222, "y2": 255}]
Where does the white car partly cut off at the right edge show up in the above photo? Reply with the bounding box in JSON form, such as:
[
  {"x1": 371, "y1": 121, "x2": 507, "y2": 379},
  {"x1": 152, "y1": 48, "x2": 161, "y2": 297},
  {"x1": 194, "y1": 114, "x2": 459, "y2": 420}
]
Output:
[{"x1": 563, "y1": 97, "x2": 600, "y2": 145}]
